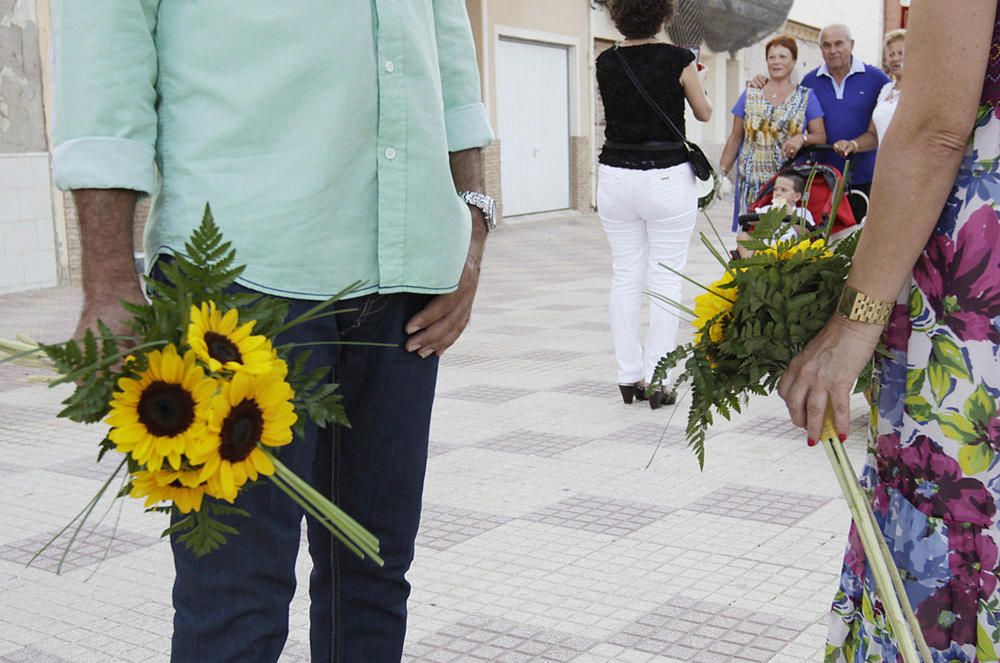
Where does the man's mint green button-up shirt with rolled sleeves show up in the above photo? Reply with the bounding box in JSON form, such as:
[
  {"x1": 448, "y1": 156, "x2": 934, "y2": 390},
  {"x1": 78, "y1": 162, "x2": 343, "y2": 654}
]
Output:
[{"x1": 52, "y1": 0, "x2": 493, "y2": 299}]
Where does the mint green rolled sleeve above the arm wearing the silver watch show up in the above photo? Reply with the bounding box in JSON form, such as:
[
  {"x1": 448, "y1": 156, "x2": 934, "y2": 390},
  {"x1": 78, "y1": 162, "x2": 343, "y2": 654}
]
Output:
[{"x1": 434, "y1": 0, "x2": 493, "y2": 152}]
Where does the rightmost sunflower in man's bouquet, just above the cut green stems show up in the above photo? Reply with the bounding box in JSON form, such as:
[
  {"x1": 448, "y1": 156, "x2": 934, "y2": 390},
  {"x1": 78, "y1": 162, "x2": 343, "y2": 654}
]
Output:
[{"x1": 190, "y1": 360, "x2": 297, "y2": 502}]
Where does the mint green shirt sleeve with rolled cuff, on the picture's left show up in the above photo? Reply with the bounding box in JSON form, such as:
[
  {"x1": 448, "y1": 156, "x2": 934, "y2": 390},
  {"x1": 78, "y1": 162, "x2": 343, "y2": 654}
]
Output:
[{"x1": 52, "y1": 0, "x2": 160, "y2": 193}]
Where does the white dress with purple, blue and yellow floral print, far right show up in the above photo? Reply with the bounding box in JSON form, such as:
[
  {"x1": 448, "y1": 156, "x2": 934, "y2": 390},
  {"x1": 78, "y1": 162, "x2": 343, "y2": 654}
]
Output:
[{"x1": 825, "y1": 11, "x2": 1000, "y2": 663}]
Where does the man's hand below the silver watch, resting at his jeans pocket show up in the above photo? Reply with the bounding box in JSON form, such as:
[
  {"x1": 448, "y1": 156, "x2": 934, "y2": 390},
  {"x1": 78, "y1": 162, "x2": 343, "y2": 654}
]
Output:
[{"x1": 406, "y1": 224, "x2": 486, "y2": 359}]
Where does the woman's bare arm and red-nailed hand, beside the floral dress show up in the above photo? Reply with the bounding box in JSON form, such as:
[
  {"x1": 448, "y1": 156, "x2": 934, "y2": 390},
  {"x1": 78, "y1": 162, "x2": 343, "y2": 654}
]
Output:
[{"x1": 778, "y1": 0, "x2": 997, "y2": 440}]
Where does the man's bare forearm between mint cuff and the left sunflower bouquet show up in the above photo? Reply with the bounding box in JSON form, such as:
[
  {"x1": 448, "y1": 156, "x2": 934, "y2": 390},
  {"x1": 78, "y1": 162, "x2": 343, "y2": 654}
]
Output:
[{"x1": 73, "y1": 189, "x2": 138, "y2": 302}]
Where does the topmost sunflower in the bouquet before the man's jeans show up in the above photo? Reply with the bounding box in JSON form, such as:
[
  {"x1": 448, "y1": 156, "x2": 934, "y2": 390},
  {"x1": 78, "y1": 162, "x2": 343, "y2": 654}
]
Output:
[{"x1": 187, "y1": 302, "x2": 276, "y2": 374}]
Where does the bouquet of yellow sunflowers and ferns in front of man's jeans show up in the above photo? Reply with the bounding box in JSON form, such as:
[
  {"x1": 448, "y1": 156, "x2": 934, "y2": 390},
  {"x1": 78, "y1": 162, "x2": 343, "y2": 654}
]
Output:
[{"x1": 0, "y1": 207, "x2": 382, "y2": 565}]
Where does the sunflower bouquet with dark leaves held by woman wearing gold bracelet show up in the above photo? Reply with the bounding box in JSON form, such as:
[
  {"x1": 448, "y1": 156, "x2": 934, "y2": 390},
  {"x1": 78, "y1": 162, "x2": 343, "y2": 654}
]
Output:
[{"x1": 653, "y1": 209, "x2": 931, "y2": 663}]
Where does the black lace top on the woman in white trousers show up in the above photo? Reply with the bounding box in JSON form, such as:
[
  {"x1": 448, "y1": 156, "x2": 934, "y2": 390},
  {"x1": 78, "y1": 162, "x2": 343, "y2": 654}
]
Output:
[{"x1": 597, "y1": 44, "x2": 694, "y2": 170}]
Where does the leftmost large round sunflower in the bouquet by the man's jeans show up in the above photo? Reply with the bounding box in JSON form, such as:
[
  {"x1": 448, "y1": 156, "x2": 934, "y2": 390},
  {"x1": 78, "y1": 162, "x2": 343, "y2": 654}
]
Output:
[{"x1": 104, "y1": 344, "x2": 217, "y2": 472}]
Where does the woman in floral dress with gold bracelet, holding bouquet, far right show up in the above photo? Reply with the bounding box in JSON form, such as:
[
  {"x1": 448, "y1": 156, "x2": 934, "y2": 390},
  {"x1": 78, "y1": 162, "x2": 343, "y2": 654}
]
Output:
[{"x1": 778, "y1": 0, "x2": 1000, "y2": 663}]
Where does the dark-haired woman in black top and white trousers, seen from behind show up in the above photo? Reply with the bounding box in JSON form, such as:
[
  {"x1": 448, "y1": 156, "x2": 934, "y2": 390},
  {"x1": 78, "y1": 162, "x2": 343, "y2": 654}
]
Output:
[{"x1": 597, "y1": 0, "x2": 712, "y2": 408}]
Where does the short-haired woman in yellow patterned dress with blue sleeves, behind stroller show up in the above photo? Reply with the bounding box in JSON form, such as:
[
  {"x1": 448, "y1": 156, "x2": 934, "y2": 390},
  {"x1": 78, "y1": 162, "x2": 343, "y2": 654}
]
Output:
[{"x1": 719, "y1": 36, "x2": 826, "y2": 230}]
